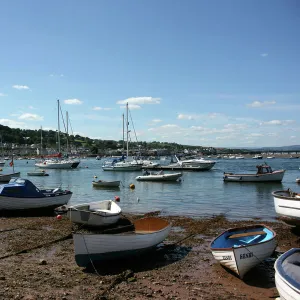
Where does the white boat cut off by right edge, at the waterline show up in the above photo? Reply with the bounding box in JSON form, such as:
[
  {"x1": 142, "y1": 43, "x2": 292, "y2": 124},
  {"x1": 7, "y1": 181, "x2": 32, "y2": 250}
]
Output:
[{"x1": 272, "y1": 189, "x2": 300, "y2": 225}]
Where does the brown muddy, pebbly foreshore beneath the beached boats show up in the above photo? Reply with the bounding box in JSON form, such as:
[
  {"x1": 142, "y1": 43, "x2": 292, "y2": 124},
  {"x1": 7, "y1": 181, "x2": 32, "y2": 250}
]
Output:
[{"x1": 0, "y1": 212, "x2": 300, "y2": 300}]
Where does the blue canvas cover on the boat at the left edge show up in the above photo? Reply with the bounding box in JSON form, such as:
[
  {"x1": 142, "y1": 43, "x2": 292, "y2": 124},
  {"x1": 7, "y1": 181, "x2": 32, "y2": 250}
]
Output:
[{"x1": 0, "y1": 178, "x2": 45, "y2": 198}]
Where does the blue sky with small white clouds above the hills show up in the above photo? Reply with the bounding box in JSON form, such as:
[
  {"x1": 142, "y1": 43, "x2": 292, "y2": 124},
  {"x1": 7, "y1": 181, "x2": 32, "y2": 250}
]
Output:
[{"x1": 0, "y1": 0, "x2": 300, "y2": 147}]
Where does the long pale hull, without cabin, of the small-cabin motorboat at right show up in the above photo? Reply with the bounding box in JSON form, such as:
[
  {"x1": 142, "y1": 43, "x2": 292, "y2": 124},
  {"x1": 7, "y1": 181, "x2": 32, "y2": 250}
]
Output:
[{"x1": 223, "y1": 170, "x2": 285, "y2": 182}]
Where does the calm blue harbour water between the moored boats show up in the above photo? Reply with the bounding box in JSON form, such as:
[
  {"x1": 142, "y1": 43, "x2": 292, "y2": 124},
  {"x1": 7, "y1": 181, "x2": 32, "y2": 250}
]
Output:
[{"x1": 3, "y1": 158, "x2": 300, "y2": 220}]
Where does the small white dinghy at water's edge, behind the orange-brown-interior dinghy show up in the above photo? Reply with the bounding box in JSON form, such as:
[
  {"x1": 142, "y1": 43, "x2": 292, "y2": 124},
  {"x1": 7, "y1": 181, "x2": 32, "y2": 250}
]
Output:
[{"x1": 67, "y1": 200, "x2": 122, "y2": 227}]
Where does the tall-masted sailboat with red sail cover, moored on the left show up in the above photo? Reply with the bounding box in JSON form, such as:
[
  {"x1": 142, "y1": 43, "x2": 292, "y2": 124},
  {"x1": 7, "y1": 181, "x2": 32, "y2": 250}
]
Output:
[{"x1": 35, "y1": 100, "x2": 77, "y2": 169}]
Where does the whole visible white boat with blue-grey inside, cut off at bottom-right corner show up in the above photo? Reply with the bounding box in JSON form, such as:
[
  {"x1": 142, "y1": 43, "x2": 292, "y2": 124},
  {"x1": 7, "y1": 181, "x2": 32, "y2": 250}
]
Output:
[{"x1": 274, "y1": 248, "x2": 300, "y2": 300}]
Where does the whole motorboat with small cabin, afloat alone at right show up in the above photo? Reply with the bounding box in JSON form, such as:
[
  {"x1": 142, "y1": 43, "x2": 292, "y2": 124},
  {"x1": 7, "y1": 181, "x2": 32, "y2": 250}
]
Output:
[{"x1": 223, "y1": 164, "x2": 285, "y2": 182}]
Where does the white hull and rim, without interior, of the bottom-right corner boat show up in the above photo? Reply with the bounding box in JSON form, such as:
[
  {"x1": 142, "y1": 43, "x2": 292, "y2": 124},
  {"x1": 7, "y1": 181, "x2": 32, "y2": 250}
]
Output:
[{"x1": 274, "y1": 249, "x2": 300, "y2": 300}]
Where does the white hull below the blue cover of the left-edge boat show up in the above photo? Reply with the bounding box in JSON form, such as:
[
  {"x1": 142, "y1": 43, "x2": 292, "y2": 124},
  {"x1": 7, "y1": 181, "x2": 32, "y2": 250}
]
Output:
[{"x1": 0, "y1": 193, "x2": 72, "y2": 210}]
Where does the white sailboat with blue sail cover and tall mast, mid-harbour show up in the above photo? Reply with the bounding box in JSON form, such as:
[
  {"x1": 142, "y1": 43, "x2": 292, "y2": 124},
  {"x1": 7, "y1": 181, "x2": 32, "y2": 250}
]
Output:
[{"x1": 102, "y1": 103, "x2": 143, "y2": 171}]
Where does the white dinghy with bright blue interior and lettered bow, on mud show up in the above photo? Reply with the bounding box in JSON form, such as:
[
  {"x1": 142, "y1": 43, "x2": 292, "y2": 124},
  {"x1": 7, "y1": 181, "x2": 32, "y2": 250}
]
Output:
[{"x1": 210, "y1": 224, "x2": 276, "y2": 278}]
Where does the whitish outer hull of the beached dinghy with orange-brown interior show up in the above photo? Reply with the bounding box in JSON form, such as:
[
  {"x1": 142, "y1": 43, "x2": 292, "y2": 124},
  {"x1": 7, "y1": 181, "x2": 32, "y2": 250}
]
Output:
[{"x1": 73, "y1": 218, "x2": 171, "y2": 267}]
